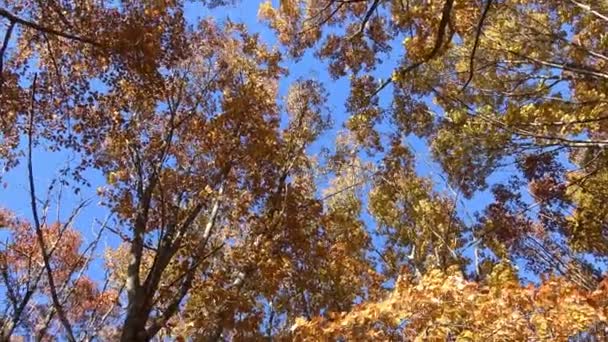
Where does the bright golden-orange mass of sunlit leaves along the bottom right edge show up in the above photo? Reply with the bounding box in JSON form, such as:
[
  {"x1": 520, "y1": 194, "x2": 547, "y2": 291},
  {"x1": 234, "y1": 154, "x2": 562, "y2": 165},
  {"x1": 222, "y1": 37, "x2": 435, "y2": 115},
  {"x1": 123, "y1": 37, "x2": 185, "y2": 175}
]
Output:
[{"x1": 292, "y1": 267, "x2": 606, "y2": 341}]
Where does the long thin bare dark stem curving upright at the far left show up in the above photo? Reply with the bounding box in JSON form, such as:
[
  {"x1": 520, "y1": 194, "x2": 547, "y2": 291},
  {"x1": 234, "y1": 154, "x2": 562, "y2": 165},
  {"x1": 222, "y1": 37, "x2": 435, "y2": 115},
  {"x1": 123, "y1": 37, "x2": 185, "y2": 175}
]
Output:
[{"x1": 27, "y1": 73, "x2": 76, "y2": 342}]
